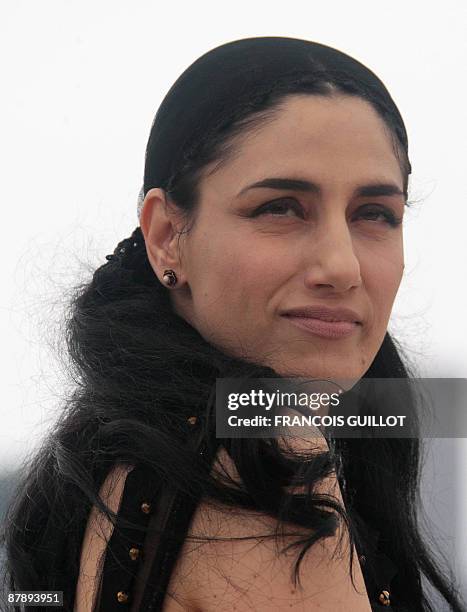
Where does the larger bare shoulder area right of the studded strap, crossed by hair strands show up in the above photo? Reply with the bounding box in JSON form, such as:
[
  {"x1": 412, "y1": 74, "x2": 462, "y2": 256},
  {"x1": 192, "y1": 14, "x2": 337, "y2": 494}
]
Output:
[{"x1": 179, "y1": 445, "x2": 371, "y2": 612}]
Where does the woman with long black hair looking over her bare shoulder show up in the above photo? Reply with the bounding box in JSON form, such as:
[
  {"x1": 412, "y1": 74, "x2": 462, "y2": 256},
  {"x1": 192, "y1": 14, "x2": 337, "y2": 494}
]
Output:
[{"x1": 5, "y1": 37, "x2": 462, "y2": 612}]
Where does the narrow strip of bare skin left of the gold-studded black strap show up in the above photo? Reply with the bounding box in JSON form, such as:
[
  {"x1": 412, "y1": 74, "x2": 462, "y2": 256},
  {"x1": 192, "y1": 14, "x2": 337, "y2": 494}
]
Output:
[{"x1": 74, "y1": 464, "x2": 133, "y2": 612}]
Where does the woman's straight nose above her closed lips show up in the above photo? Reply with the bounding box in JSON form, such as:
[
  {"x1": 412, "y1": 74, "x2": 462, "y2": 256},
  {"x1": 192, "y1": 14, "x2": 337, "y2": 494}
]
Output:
[{"x1": 305, "y1": 217, "x2": 362, "y2": 293}]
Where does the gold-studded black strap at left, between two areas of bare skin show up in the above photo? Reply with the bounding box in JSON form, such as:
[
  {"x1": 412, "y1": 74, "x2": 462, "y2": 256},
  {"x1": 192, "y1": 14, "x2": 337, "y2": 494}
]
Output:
[{"x1": 98, "y1": 467, "x2": 197, "y2": 612}]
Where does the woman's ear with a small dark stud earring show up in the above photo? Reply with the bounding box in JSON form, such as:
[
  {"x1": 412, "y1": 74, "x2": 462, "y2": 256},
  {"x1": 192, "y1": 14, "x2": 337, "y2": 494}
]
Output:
[{"x1": 140, "y1": 187, "x2": 182, "y2": 283}]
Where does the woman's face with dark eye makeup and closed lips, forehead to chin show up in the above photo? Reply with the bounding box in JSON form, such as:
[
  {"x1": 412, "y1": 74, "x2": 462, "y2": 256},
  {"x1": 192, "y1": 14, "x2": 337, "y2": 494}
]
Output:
[{"x1": 146, "y1": 95, "x2": 405, "y2": 379}]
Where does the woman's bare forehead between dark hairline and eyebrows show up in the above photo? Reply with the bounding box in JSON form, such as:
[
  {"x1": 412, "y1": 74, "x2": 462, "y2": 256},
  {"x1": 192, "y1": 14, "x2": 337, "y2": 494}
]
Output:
[{"x1": 202, "y1": 94, "x2": 403, "y2": 195}]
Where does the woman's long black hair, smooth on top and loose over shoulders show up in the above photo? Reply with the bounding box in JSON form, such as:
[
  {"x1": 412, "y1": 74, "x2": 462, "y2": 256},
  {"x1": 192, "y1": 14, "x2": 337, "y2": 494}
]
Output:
[{"x1": 3, "y1": 38, "x2": 462, "y2": 612}]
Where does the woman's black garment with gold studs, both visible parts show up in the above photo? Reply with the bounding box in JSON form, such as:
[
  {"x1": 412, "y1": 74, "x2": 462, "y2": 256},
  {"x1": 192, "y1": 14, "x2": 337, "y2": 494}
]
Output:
[{"x1": 96, "y1": 467, "x2": 407, "y2": 612}]
